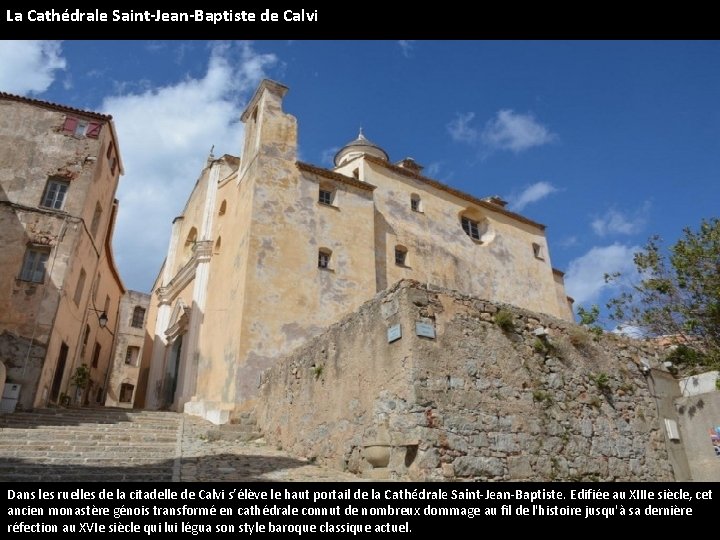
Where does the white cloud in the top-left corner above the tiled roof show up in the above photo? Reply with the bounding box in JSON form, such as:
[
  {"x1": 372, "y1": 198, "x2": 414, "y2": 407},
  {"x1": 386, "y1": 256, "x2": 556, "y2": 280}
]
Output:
[{"x1": 0, "y1": 40, "x2": 67, "y2": 95}]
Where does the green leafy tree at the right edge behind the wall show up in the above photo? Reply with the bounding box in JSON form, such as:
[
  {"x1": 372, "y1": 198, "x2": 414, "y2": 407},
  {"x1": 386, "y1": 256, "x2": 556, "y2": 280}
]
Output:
[{"x1": 605, "y1": 218, "x2": 720, "y2": 369}]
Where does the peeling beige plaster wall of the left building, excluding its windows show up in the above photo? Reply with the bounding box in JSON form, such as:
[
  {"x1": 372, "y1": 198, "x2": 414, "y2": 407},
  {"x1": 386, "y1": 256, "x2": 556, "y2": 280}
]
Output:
[{"x1": 0, "y1": 98, "x2": 122, "y2": 408}]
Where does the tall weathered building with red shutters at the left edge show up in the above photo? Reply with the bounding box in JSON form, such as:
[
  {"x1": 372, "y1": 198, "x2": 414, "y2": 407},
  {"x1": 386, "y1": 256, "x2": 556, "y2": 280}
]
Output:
[{"x1": 0, "y1": 93, "x2": 124, "y2": 409}]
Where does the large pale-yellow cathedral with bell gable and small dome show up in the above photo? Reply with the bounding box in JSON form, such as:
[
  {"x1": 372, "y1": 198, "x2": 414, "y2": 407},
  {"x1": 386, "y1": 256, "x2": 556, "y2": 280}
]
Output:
[{"x1": 146, "y1": 80, "x2": 572, "y2": 423}]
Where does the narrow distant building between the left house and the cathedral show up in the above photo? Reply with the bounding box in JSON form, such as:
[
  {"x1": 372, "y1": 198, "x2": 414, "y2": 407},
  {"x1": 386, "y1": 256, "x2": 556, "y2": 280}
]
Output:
[{"x1": 105, "y1": 291, "x2": 150, "y2": 409}]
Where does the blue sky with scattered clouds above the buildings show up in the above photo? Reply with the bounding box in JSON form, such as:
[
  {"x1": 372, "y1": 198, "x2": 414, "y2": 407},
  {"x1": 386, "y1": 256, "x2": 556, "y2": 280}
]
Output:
[{"x1": 0, "y1": 41, "x2": 720, "y2": 322}]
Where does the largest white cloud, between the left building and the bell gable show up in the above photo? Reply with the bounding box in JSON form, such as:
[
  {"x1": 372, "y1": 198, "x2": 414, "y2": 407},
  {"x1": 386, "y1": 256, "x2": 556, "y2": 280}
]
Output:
[{"x1": 102, "y1": 43, "x2": 277, "y2": 290}]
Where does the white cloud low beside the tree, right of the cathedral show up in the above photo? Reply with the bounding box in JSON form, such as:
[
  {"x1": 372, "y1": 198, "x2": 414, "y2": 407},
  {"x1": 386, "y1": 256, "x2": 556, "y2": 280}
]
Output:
[{"x1": 565, "y1": 243, "x2": 640, "y2": 305}]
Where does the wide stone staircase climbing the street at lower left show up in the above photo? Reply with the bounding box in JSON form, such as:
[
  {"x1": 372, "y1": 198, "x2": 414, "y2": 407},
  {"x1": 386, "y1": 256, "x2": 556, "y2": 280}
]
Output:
[{"x1": 0, "y1": 408, "x2": 183, "y2": 482}]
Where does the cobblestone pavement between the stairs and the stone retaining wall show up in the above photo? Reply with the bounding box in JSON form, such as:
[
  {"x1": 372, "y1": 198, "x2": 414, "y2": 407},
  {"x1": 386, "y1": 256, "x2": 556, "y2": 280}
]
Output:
[{"x1": 180, "y1": 416, "x2": 361, "y2": 482}]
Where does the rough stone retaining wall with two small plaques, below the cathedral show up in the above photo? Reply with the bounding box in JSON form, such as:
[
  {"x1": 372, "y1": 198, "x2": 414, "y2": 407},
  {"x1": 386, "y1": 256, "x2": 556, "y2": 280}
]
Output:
[{"x1": 256, "y1": 281, "x2": 675, "y2": 481}]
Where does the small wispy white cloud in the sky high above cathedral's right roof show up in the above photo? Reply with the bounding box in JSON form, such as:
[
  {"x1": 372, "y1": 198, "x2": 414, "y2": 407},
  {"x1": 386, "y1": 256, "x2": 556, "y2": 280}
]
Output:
[{"x1": 482, "y1": 109, "x2": 557, "y2": 153}]
